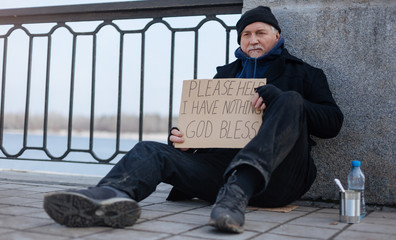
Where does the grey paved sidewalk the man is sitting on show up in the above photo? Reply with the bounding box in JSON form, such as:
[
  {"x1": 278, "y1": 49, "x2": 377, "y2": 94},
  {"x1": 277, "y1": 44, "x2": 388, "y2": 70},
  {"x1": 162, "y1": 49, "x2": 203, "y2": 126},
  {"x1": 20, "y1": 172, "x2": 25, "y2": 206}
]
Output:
[{"x1": 0, "y1": 171, "x2": 396, "y2": 240}]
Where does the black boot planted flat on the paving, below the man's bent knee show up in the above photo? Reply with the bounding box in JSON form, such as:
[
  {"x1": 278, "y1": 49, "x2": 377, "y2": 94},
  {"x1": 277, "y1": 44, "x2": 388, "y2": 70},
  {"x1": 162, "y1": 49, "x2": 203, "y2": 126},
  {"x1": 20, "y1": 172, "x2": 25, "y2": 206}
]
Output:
[{"x1": 209, "y1": 176, "x2": 248, "y2": 233}]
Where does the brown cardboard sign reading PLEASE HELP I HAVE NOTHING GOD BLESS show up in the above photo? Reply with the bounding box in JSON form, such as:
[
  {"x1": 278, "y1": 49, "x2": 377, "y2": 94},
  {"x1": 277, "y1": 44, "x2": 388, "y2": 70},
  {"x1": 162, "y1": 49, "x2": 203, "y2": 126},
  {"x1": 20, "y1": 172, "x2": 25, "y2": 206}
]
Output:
[{"x1": 175, "y1": 78, "x2": 266, "y2": 148}]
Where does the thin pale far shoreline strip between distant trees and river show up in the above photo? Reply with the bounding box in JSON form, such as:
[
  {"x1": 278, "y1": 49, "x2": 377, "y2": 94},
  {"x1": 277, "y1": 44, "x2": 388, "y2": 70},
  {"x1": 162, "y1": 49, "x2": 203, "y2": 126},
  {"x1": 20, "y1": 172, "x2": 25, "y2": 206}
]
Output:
[{"x1": 4, "y1": 129, "x2": 168, "y2": 141}]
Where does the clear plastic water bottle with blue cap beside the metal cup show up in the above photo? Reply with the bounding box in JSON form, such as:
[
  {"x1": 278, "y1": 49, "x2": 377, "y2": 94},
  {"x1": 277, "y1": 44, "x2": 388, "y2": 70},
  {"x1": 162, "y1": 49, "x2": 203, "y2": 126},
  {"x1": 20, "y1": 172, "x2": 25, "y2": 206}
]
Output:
[{"x1": 348, "y1": 160, "x2": 366, "y2": 219}]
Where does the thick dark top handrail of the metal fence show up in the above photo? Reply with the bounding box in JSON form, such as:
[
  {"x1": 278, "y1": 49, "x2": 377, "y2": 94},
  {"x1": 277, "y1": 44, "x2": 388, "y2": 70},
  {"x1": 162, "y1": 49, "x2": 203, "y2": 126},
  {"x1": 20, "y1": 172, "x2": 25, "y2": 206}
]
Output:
[{"x1": 0, "y1": 0, "x2": 243, "y2": 24}]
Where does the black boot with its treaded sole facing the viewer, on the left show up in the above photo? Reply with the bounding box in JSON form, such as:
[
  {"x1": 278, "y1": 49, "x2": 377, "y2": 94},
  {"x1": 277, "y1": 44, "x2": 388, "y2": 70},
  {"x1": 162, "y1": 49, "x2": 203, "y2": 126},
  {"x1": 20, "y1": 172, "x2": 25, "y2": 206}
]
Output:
[{"x1": 44, "y1": 187, "x2": 140, "y2": 228}]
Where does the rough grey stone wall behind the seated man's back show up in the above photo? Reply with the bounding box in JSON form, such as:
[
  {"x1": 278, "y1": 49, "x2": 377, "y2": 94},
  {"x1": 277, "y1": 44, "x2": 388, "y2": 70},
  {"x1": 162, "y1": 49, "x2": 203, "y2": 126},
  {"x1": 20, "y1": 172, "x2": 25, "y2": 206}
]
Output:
[{"x1": 243, "y1": 0, "x2": 396, "y2": 206}]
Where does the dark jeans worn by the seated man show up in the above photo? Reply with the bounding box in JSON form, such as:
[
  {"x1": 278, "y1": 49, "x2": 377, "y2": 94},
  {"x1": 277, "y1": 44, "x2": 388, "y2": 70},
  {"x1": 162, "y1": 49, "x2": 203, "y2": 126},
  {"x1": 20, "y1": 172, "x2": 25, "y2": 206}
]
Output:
[{"x1": 98, "y1": 92, "x2": 316, "y2": 207}]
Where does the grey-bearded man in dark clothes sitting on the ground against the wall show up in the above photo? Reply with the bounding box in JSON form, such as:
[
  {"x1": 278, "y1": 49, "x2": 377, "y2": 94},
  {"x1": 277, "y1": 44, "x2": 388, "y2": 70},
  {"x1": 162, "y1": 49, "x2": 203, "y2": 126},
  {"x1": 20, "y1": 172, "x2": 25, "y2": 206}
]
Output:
[{"x1": 44, "y1": 6, "x2": 343, "y2": 233}]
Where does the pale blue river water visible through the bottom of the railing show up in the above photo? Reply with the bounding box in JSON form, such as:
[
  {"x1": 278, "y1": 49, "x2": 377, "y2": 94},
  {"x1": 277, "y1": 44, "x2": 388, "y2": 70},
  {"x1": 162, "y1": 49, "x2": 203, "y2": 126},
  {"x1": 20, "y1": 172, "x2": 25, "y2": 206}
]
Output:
[{"x1": 0, "y1": 133, "x2": 165, "y2": 176}]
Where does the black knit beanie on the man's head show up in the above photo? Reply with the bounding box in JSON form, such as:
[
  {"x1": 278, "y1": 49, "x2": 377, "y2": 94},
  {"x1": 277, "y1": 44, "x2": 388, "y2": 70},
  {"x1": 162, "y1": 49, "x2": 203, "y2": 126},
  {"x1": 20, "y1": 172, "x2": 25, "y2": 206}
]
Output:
[{"x1": 237, "y1": 6, "x2": 281, "y2": 44}]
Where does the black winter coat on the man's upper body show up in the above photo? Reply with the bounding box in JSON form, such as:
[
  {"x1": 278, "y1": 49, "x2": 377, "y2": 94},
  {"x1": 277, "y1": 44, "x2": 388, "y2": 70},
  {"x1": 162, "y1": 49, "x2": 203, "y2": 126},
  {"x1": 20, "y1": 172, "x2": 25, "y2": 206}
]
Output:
[{"x1": 214, "y1": 49, "x2": 344, "y2": 138}]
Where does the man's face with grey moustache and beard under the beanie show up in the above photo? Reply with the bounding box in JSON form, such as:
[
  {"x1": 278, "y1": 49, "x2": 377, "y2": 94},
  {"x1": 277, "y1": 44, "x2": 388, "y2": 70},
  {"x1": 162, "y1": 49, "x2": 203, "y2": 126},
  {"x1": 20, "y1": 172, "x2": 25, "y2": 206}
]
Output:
[{"x1": 241, "y1": 22, "x2": 280, "y2": 58}]
